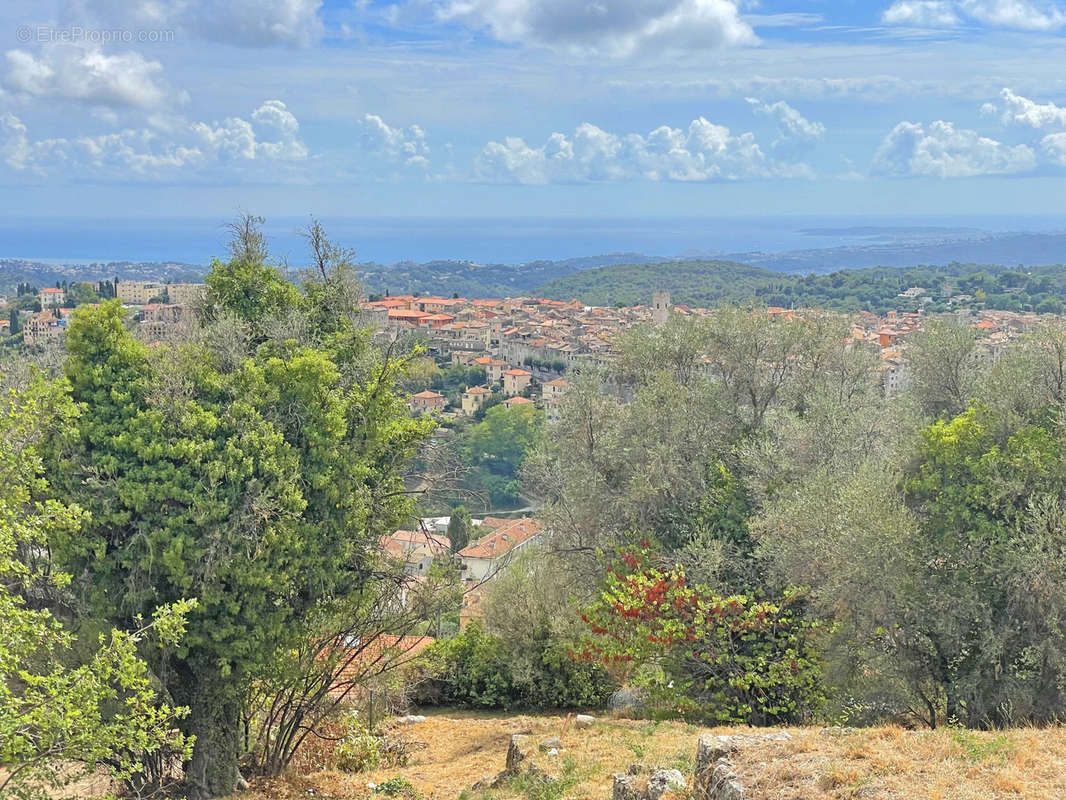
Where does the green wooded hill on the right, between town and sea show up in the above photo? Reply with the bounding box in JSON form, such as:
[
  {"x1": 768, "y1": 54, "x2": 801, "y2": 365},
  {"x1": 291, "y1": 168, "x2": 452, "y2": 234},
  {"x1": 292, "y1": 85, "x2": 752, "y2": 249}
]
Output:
[{"x1": 536, "y1": 261, "x2": 1066, "y2": 314}]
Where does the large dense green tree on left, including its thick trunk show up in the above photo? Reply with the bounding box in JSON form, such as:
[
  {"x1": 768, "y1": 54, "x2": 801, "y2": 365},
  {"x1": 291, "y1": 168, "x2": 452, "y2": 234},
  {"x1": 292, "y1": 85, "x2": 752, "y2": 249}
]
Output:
[{"x1": 49, "y1": 220, "x2": 429, "y2": 796}]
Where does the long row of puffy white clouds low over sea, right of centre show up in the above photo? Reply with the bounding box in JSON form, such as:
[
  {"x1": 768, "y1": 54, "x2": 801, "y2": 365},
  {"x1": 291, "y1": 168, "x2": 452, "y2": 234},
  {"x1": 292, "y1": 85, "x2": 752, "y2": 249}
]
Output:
[{"x1": 474, "y1": 117, "x2": 811, "y2": 183}]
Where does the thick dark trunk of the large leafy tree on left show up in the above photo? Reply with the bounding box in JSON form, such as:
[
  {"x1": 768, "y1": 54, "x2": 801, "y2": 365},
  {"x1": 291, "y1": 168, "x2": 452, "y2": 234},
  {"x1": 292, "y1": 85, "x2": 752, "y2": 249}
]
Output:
[{"x1": 180, "y1": 670, "x2": 242, "y2": 800}]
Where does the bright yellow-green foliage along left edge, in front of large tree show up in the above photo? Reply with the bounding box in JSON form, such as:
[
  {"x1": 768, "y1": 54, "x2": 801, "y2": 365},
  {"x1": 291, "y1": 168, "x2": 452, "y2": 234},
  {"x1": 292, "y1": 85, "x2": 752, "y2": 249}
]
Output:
[{"x1": 0, "y1": 378, "x2": 195, "y2": 799}]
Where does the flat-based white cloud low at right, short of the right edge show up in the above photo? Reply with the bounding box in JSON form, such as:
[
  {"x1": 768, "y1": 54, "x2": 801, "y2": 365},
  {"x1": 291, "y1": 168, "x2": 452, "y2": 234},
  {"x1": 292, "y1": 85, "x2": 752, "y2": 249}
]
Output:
[{"x1": 871, "y1": 119, "x2": 1036, "y2": 178}]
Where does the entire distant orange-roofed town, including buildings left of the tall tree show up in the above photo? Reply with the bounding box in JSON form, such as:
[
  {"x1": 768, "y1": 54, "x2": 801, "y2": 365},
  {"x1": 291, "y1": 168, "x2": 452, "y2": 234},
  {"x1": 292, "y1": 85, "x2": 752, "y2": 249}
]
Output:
[{"x1": 0, "y1": 281, "x2": 1047, "y2": 409}]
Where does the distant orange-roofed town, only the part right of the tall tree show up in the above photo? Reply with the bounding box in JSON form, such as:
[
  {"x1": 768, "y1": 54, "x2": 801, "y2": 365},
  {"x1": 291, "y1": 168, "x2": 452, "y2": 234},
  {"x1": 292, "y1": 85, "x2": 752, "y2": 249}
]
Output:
[{"x1": 364, "y1": 287, "x2": 1047, "y2": 419}]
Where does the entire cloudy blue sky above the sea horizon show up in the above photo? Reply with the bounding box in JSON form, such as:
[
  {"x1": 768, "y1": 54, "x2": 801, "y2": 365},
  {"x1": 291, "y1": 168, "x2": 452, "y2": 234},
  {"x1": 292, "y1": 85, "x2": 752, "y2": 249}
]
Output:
[{"x1": 0, "y1": 0, "x2": 1066, "y2": 218}]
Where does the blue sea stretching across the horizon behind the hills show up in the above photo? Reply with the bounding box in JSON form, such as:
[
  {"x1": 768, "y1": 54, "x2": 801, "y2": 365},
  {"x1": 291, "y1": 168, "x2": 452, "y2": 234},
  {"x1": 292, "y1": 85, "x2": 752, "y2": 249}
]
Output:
[{"x1": 0, "y1": 215, "x2": 1066, "y2": 266}]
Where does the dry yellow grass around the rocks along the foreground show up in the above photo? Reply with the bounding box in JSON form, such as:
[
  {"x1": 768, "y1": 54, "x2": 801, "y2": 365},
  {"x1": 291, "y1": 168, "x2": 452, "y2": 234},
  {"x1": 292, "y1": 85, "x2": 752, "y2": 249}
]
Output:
[{"x1": 231, "y1": 711, "x2": 1066, "y2": 800}]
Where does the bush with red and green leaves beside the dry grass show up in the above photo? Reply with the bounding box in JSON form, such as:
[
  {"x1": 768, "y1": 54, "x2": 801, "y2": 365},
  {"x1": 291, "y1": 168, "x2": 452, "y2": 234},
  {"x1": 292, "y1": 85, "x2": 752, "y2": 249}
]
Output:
[{"x1": 580, "y1": 553, "x2": 823, "y2": 725}]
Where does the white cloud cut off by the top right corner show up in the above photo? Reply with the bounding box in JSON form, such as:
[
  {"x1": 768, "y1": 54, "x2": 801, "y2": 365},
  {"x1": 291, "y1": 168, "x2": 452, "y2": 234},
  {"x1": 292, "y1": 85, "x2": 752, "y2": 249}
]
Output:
[{"x1": 882, "y1": 0, "x2": 1066, "y2": 31}]
